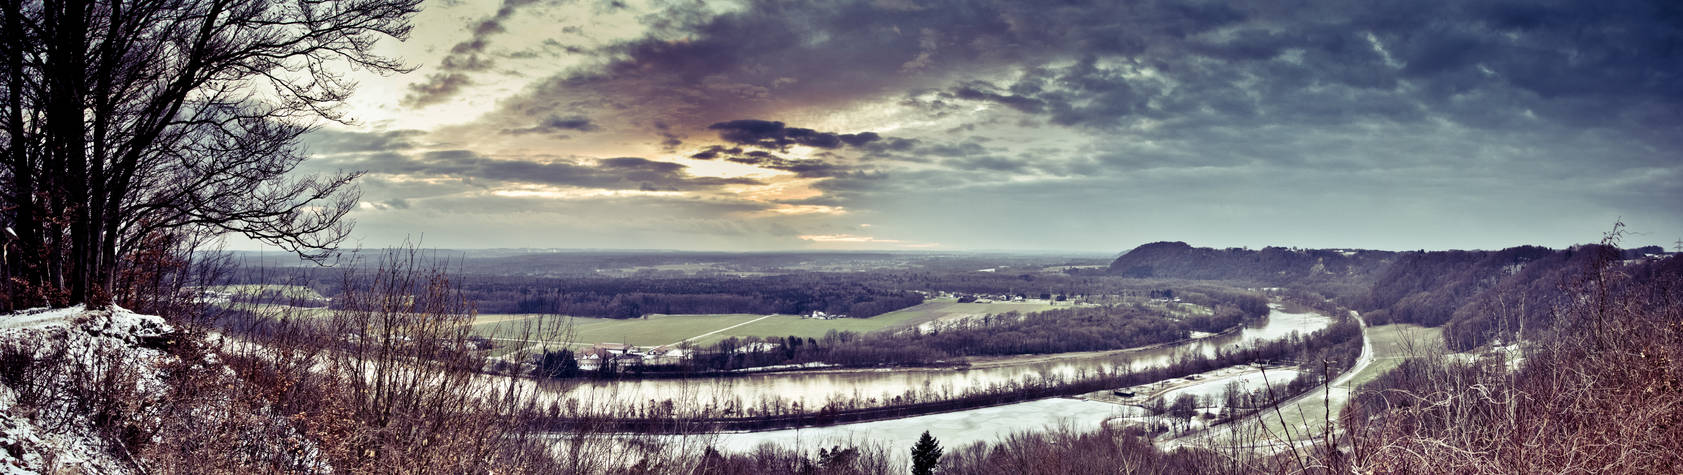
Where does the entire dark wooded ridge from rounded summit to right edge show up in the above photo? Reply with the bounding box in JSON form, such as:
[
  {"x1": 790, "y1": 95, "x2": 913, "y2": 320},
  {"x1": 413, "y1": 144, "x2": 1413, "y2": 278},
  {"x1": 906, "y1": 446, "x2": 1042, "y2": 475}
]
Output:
[{"x1": 1111, "y1": 243, "x2": 1676, "y2": 350}]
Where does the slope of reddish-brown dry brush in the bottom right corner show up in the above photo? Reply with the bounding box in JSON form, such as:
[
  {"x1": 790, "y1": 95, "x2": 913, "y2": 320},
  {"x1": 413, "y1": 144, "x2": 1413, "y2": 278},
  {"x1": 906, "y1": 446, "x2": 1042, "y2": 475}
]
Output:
[{"x1": 1336, "y1": 252, "x2": 1683, "y2": 473}]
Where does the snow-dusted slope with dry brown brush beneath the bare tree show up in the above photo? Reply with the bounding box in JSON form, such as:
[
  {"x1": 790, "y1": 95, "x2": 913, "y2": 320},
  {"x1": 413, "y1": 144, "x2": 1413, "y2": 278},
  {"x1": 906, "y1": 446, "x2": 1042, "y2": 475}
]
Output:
[{"x1": 0, "y1": 307, "x2": 323, "y2": 475}]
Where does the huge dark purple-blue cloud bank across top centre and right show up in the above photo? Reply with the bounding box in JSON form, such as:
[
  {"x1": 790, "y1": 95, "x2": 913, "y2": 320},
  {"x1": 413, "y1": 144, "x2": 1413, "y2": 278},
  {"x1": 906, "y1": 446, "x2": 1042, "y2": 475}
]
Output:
[{"x1": 498, "y1": 0, "x2": 1683, "y2": 148}]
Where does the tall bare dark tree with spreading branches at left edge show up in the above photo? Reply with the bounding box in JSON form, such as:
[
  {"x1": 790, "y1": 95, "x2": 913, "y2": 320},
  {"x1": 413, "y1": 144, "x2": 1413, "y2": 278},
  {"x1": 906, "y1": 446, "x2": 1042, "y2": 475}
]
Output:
[{"x1": 0, "y1": 0, "x2": 419, "y2": 305}]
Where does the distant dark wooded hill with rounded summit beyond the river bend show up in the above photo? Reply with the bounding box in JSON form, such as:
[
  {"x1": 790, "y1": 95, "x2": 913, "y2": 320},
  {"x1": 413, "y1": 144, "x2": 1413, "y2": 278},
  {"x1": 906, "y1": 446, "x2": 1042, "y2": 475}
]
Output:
[{"x1": 1111, "y1": 241, "x2": 1399, "y2": 286}]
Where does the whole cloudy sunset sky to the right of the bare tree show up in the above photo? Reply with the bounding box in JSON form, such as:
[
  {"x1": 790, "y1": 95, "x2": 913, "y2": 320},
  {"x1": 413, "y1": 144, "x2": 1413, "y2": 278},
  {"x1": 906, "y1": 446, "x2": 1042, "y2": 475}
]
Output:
[{"x1": 255, "y1": 0, "x2": 1683, "y2": 253}]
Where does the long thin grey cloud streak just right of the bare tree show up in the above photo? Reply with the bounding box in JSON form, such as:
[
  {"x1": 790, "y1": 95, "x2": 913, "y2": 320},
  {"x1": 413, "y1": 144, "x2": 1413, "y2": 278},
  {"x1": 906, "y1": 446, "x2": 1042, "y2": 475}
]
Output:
[{"x1": 313, "y1": 150, "x2": 759, "y2": 190}]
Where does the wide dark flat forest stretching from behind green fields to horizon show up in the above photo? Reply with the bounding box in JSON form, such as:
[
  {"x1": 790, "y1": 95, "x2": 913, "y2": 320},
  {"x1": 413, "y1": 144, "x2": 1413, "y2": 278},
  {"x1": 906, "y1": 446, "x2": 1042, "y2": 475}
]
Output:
[{"x1": 231, "y1": 253, "x2": 1266, "y2": 318}]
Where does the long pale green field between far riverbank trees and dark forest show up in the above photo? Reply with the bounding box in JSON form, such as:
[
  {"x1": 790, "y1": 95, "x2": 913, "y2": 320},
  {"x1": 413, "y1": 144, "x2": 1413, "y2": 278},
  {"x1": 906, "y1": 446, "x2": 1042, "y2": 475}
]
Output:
[{"x1": 473, "y1": 298, "x2": 1069, "y2": 345}]
